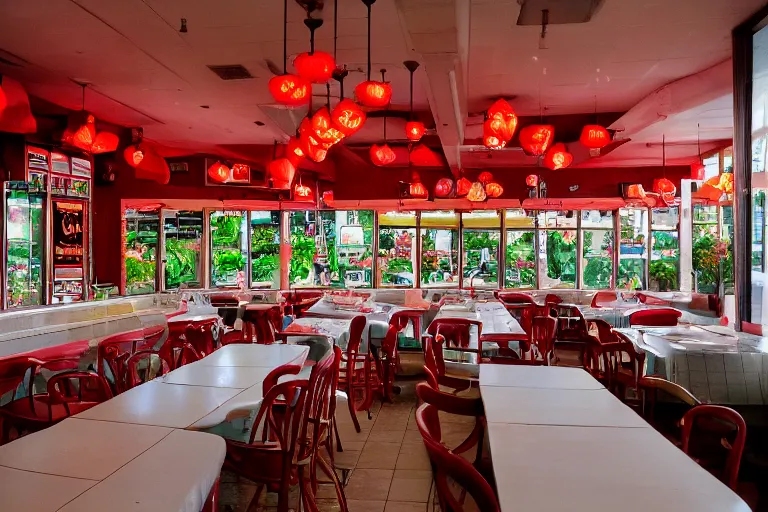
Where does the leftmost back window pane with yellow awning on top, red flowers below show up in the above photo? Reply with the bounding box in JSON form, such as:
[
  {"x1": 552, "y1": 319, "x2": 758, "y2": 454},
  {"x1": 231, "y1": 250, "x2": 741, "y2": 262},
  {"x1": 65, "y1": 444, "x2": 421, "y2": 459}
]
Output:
[{"x1": 377, "y1": 211, "x2": 416, "y2": 288}]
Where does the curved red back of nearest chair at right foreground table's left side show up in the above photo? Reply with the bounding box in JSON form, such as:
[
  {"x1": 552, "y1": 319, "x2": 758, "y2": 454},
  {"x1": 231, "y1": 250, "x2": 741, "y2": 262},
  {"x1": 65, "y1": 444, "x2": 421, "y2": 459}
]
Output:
[{"x1": 416, "y1": 403, "x2": 501, "y2": 512}]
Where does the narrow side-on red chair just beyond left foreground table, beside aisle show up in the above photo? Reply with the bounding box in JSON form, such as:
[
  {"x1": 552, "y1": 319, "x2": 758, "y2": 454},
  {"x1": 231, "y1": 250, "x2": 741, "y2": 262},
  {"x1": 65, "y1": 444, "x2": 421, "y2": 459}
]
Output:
[{"x1": 339, "y1": 315, "x2": 380, "y2": 432}]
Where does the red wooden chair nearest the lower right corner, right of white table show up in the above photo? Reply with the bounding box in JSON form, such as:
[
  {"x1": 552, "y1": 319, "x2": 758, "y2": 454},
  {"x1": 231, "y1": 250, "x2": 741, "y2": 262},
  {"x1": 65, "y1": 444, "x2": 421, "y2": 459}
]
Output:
[{"x1": 682, "y1": 405, "x2": 747, "y2": 491}]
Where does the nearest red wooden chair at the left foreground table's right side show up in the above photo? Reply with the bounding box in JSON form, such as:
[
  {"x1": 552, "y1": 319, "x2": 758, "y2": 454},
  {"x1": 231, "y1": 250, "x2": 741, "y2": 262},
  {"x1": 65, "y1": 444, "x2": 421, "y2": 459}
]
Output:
[{"x1": 224, "y1": 379, "x2": 309, "y2": 512}]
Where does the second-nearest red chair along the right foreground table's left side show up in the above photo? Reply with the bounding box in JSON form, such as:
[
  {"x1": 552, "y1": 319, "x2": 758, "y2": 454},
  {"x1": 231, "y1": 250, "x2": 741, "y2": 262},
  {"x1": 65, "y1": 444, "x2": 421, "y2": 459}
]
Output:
[{"x1": 416, "y1": 382, "x2": 486, "y2": 474}]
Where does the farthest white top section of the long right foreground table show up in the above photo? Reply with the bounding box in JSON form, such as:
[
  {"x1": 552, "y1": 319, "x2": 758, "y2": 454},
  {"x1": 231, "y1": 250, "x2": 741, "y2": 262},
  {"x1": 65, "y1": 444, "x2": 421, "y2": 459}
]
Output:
[{"x1": 480, "y1": 364, "x2": 605, "y2": 390}]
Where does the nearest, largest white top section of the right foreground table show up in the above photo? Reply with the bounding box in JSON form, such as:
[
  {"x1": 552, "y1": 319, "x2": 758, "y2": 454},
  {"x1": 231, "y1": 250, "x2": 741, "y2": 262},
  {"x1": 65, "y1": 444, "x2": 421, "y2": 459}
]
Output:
[{"x1": 488, "y1": 423, "x2": 750, "y2": 512}]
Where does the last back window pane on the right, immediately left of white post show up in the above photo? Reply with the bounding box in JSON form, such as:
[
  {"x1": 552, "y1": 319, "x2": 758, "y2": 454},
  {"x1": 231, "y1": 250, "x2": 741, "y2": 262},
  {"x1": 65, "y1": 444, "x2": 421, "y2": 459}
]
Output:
[{"x1": 648, "y1": 206, "x2": 680, "y2": 292}]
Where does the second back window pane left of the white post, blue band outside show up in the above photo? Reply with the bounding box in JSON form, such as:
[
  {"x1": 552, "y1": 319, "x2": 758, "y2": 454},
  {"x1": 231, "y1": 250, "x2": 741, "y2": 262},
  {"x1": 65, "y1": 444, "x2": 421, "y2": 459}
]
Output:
[{"x1": 616, "y1": 208, "x2": 649, "y2": 290}]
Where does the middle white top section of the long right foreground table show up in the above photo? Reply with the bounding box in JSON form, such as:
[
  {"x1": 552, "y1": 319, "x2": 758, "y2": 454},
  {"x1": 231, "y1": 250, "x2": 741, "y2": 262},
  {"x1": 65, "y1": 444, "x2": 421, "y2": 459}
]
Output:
[{"x1": 480, "y1": 386, "x2": 648, "y2": 428}]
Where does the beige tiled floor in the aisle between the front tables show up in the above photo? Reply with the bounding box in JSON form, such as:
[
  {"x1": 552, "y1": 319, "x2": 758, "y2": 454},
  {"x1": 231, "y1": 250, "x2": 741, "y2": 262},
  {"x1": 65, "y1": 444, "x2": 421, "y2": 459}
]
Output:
[{"x1": 220, "y1": 380, "x2": 472, "y2": 512}]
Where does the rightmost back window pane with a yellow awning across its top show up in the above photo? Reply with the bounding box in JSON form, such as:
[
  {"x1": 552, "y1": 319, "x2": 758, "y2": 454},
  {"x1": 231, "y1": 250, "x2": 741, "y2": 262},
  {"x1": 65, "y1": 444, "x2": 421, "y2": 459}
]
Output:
[{"x1": 505, "y1": 210, "x2": 536, "y2": 288}]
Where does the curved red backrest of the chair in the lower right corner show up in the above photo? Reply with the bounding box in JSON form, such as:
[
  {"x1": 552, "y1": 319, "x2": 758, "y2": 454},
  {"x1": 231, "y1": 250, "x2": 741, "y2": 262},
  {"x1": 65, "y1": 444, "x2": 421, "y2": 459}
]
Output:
[{"x1": 682, "y1": 405, "x2": 747, "y2": 491}]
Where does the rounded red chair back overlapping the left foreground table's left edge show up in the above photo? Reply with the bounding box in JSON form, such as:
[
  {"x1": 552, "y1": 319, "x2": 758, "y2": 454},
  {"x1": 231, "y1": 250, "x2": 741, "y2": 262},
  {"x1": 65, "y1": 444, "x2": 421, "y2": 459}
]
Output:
[{"x1": 47, "y1": 370, "x2": 112, "y2": 415}]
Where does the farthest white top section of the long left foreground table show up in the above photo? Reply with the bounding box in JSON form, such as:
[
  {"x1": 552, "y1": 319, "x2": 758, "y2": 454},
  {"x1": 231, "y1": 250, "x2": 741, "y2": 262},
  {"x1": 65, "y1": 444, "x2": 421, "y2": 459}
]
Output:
[{"x1": 200, "y1": 344, "x2": 309, "y2": 368}]
